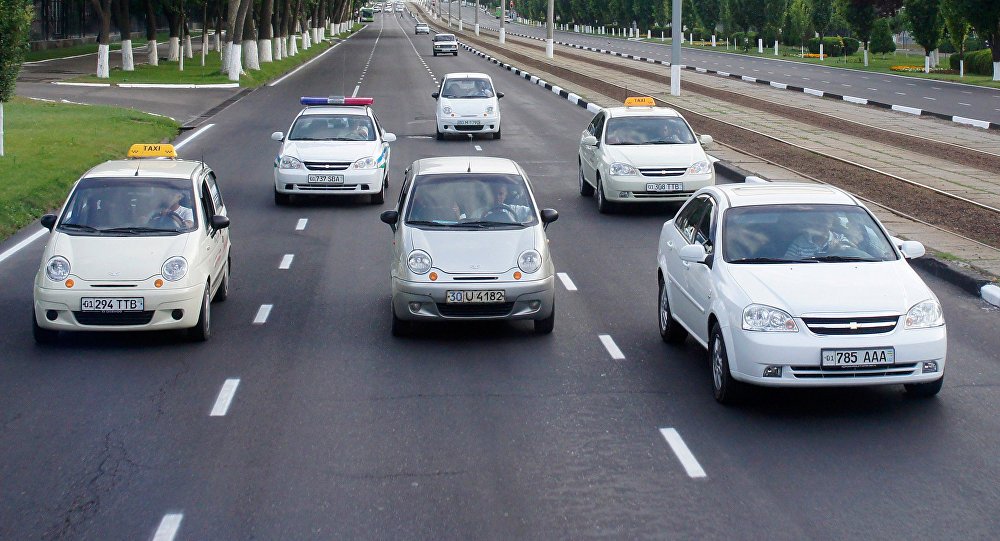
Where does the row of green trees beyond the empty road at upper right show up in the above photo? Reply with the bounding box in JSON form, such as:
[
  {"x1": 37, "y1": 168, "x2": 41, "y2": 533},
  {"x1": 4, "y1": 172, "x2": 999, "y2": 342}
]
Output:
[{"x1": 507, "y1": 0, "x2": 1000, "y2": 80}]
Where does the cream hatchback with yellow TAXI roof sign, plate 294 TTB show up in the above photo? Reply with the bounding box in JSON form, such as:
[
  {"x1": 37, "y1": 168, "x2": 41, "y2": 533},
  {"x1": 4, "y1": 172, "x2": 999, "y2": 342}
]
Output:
[{"x1": 31, "y1": 144, "x2": 230, "y2": 343}]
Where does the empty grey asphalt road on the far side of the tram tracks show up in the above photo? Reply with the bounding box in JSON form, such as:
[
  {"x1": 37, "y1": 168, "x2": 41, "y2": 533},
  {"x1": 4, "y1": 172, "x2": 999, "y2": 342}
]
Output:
[{"x1": 442, "y1": 2, "x2": 1000, "y2": 122}]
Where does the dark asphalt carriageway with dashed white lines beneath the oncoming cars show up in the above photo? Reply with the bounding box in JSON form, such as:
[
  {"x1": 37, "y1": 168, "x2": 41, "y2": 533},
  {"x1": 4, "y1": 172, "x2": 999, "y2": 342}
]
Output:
[{"x1": 0, "y1": 12, "x2": 1000, "y2": 540}]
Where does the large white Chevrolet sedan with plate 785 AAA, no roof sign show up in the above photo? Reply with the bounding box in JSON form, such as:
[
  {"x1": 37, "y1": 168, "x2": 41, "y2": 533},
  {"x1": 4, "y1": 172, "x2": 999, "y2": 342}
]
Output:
[{"x1": 657, "y1": 183, "x2": 947, "y2": 402}]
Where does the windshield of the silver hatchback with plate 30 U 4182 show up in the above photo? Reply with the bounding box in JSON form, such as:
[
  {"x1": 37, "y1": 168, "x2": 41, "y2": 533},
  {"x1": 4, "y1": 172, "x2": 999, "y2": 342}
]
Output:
[{"x1": 406, "y1": 173, "x2": 538, "y2": 229}]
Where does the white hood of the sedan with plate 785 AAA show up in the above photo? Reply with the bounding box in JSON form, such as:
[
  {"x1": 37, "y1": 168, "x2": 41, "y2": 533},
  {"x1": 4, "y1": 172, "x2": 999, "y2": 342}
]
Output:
[{"x1": 726, "y1": 260, "x2": 933, "y2": 317}]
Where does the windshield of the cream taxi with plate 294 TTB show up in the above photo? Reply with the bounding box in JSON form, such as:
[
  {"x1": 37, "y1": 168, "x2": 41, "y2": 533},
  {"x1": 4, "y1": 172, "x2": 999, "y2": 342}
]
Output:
[{"x1": 56, "y1": 178, "x2": 198, "y2": 236}]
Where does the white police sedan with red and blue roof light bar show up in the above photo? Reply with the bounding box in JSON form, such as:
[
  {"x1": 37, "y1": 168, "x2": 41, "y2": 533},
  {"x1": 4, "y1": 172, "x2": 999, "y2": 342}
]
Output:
[{"x1": 271, "y1": 97, "x2": 396, "y2": 205}]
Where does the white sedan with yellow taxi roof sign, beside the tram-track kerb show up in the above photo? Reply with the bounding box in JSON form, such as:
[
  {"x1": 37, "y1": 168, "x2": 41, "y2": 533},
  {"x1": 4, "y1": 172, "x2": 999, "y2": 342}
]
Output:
[{"x1": 578, "y1": 97, "x2": 715, "y2": 213}]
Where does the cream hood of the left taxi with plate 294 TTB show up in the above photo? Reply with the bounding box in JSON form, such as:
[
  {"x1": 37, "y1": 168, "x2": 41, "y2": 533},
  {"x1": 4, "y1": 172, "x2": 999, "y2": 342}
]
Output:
[{"x1": 50, "y1": 232, "x2": 195, "y2": 281}]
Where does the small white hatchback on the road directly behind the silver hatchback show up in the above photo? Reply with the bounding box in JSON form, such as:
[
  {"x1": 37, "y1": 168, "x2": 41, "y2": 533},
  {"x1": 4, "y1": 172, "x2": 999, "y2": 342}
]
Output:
[{"x1": 431, "y1": 73, "x2": 503, "y2": 140}]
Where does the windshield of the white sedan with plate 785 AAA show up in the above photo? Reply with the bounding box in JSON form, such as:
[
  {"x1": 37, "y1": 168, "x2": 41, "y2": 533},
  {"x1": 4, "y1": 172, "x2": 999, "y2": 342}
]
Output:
[{"x1": 722, "y1": 205, "x2": 896, "y2": 264}]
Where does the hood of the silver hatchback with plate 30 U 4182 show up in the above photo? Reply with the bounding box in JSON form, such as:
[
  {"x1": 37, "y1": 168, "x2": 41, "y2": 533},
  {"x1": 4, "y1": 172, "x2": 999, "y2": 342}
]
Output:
[{"x1": 410, "y1": 227, "x2": 535, "y2": 274}]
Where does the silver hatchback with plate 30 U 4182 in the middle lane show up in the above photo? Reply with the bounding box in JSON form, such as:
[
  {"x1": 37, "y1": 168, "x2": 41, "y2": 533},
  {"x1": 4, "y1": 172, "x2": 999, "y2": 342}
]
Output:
[{"x1": 381, "y1": 156, "x2": 559, "y2": 336}]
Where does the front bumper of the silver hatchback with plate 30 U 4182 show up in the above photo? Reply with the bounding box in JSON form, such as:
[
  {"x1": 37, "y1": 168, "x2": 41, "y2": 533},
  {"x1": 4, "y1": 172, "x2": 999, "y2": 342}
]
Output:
[{"x1": 392, "y1": 276, "x2": 555, "y2": 321}]
